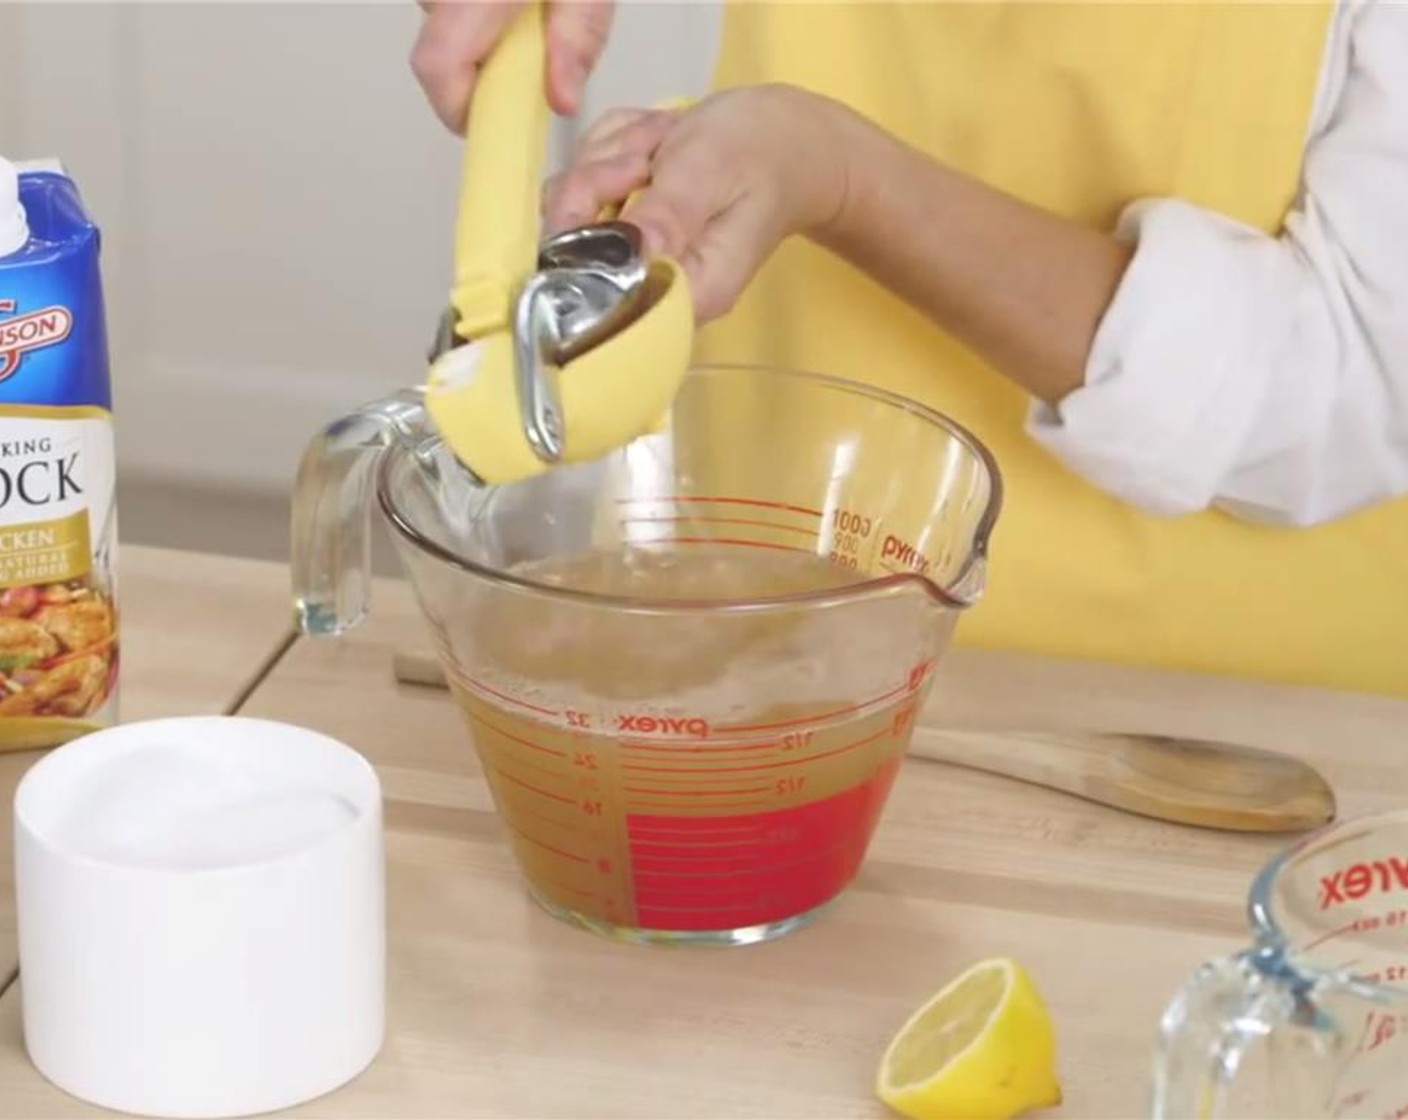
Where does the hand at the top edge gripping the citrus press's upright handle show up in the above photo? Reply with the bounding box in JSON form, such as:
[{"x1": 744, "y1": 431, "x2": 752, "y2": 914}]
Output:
[{"x1": 411, "y1": 0, "x2": 614, "y2": 135}]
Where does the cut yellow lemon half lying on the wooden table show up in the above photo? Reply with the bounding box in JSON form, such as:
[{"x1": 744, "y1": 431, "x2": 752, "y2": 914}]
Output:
[{"x1": 876, "y1": 958, "x2": 1062, "y2": 1120}]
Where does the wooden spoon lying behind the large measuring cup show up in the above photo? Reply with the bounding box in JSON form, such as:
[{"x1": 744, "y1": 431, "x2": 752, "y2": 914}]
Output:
[{"x1": 393, "y1": 651, "x2": 1335, "y2": 833}]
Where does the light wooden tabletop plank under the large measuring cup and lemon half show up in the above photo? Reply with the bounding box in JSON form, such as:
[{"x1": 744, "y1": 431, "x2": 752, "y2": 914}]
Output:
[{"x1": 0, "y1": 555, "x2": 1408, "y2": 1120}]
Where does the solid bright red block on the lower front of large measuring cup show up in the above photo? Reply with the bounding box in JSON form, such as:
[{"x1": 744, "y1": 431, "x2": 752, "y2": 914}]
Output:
[{"x1": 627, "y1": 758, "x2": 900, "y2": 930}]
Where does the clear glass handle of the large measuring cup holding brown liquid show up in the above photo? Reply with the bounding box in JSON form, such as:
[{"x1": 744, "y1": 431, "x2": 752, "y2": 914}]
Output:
[{"x1": 289, "y1": 389, "x2": 428, "y2": 637}]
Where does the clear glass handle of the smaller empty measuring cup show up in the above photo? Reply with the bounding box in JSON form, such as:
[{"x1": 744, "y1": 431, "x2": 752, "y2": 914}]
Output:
[{"x1": 1152, "y1": 950, "x2": 1342, "y2": 1120}]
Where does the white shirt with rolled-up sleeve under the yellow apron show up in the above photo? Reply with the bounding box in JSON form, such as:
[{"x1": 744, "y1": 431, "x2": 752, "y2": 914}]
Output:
[{"x1": 1028, "y1": 0, "x2": 1408, "y2": 525}]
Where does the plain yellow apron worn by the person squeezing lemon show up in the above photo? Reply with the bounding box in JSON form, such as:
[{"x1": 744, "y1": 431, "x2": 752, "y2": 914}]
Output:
[{"x1": 697, "y1": 0, "x2": 1408, "y2": 696}]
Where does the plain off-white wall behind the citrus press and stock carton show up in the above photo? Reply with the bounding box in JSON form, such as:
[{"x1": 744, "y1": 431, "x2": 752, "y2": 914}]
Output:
[{"x1": 0, "y1": 0, "x2": 718, "y2": 493}]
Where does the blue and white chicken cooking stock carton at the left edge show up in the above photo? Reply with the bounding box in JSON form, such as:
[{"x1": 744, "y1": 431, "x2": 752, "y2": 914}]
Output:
[{"x1": 0, "y1": 157, "x2": 118, "y2": 751}]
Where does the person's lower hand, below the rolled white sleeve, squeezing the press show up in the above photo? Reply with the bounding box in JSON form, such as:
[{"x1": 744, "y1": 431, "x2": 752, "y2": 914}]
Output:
[{"x1": 543, "y1": 86, "x2": 856, "y2": 323}]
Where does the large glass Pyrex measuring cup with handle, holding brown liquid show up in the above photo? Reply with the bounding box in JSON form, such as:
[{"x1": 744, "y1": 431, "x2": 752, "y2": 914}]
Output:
[{"x1": 293, "y1": 366, "x2": 1000, "y2": 944}]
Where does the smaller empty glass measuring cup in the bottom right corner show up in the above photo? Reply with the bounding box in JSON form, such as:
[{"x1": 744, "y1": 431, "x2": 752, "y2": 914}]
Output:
[{"x1": 1153, "y1": 811, "x2": 1408, "y2": 1120}]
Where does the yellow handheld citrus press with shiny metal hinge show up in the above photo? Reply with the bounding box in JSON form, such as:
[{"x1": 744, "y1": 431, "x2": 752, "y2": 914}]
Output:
[{"x1": 425, "y1": 3, "x2": 694, "y2": 485}]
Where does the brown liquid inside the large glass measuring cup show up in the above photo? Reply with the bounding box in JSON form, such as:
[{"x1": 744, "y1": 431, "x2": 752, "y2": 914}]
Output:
[{"x1": 451, "y1": 545, "x2": 936, "y2": 931}]
